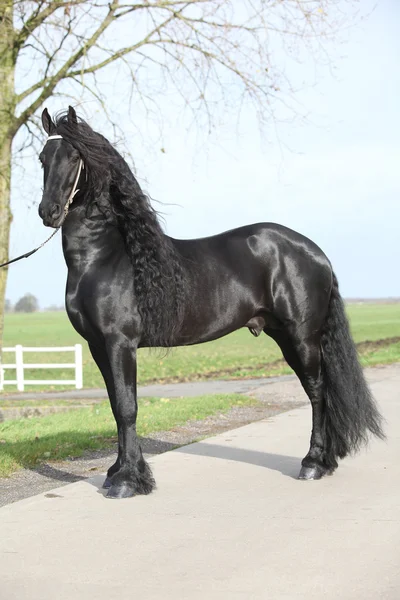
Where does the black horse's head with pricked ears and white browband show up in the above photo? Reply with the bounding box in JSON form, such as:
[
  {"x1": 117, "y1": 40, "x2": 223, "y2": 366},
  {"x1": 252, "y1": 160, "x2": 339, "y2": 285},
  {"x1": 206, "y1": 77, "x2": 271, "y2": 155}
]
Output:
[{"x1": 39, "y1": 106, "x2": 84, "y2": 227}]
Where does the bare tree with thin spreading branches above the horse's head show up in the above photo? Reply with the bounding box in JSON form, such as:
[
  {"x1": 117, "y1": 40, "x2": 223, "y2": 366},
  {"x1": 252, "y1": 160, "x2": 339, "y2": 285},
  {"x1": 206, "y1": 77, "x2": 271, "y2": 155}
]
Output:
[{"x1": 0, "y1": 0, "x2": 353, "y2": 344}]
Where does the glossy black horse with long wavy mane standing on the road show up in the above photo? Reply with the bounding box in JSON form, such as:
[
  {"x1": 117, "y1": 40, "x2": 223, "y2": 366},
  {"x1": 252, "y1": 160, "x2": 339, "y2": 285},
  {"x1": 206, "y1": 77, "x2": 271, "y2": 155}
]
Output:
[{"x1": 39, "y1": 107, "x2": 384, "y2": 498}]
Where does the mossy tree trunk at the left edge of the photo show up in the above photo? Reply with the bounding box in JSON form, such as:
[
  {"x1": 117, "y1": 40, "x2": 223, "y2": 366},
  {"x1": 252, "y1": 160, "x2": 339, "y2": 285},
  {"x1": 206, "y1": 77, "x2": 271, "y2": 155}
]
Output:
[{"x1": 0, "y1": 0, "x2": 16, "y2": 356}]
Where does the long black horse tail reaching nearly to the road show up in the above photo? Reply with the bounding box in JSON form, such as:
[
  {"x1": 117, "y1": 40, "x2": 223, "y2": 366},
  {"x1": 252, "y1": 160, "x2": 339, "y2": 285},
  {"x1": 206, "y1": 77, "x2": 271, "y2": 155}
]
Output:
[{"x1": 321, "y1": 274, "x2": 385, "y2": 462}]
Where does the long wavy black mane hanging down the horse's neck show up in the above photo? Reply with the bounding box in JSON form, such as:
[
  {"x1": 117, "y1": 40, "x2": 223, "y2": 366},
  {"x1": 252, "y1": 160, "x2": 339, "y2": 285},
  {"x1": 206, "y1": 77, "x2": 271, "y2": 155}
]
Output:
[{"x1": 51, "y1": 113, "x2": 185, "y2": 347}]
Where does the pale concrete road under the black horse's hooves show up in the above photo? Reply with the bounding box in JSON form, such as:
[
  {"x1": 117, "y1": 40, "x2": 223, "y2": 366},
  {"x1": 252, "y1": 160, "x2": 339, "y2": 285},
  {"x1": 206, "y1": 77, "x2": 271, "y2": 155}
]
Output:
[{"x1": 0, "y1": 366, "x2": 400, "y2": 600}]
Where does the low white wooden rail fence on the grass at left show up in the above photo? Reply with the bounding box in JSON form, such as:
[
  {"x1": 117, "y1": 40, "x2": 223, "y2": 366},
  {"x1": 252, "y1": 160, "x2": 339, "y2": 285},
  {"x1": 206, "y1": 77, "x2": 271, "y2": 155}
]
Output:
[{"x1": 0, "y1": 344, "x2": 83, "y2": 392}]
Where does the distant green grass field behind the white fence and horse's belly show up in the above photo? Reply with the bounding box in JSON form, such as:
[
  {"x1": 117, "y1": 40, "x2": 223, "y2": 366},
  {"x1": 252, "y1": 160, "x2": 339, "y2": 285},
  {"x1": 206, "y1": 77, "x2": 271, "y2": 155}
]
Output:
[{"x1": 3, "y1": 303, "x2": 400, "y2": 392}]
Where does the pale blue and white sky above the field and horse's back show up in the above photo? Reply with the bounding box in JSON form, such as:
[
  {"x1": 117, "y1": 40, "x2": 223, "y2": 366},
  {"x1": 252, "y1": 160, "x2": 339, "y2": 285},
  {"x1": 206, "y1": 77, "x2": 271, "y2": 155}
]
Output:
[{"x1": 7, "y1": 0, "x2": 400, "y2": 307}]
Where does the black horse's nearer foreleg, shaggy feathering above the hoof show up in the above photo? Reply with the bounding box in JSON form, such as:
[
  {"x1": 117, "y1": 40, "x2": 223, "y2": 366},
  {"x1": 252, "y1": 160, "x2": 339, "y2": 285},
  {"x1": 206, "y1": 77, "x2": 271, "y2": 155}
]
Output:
[{"x1": 101, "y1": 337, "x2": 155, "y2": 498}]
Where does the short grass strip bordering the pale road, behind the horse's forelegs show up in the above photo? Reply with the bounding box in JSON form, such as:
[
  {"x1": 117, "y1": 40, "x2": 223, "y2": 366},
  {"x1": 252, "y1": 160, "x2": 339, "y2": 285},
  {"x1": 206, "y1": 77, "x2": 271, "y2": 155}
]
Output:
[{"x1": 0, "y1": 394, "x2": 257, "y2": 477}]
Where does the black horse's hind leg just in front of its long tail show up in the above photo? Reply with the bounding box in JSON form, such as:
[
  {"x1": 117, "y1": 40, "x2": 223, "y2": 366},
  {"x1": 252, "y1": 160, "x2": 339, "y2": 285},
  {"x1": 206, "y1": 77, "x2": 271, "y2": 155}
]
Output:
[{"x1": 265, "y1": 330, "x2": 337, "y2": 479}]
